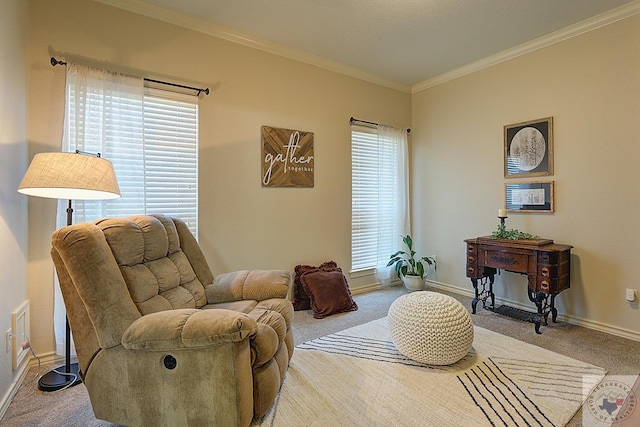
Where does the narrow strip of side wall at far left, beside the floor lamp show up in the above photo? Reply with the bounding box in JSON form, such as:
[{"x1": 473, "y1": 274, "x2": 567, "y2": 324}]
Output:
[{"x1": 0, "y1": 0, "x2": 29, "y2": 410}]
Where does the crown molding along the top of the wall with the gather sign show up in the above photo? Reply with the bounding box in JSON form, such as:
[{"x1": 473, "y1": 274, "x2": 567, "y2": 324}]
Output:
[{"x1": 94, "y1": 0, "x2": 411, "y2": 93}]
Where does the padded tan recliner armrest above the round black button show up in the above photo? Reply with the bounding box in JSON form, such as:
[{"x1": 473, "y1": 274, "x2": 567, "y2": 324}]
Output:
[{"x1": 122, "y1": 309, "x2": 258, "y2": 350}]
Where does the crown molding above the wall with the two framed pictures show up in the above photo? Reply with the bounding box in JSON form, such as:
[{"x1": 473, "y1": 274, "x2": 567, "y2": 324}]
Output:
[{"x1": 411, "y1": 0, "x2": 640, "y2": 94}]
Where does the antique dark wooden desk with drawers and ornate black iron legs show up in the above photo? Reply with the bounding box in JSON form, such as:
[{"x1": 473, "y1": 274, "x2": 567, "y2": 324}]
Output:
[{"x1": 465, "y1": 236, "x2": 573, "y2": 334}]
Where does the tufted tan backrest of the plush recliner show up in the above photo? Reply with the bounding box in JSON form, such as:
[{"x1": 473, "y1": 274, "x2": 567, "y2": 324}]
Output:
[{"x1": 51, "y1": 215, "x2": 213, "y2": 369}]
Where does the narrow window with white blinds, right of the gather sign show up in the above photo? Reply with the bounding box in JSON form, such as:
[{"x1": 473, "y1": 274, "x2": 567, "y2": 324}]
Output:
[{"x1": 351, "y1": 126, "x2": 399, "y2": 271}]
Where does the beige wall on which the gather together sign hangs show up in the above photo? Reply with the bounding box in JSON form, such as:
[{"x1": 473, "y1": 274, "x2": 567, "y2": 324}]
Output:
[{"x1": 29, "y1": 0, "x2": 411, "y2": 353}]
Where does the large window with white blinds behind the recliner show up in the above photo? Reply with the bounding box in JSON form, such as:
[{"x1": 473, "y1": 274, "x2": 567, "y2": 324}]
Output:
[{"x1": 63, "y1": 73, "x2": 198, "y2": 236}]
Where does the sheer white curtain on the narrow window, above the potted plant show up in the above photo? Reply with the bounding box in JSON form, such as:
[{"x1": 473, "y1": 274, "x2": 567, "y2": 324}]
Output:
[{"x1": 376, "y1": 125, "x2": 411, "y2": 285}]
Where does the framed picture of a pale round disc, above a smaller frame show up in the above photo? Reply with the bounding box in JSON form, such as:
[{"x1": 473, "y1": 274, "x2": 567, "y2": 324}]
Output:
[{"x1": 504, "y1": 117, "x2": 553, "y2": 178}]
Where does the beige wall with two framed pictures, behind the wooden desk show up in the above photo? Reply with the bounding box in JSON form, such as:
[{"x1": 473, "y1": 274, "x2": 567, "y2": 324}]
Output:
[{"x1": 412, "y1": 15, "x2": 640, "y2": 339}]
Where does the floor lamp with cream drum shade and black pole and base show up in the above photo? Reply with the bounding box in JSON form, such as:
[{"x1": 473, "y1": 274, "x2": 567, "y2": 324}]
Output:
[{"x1": 18, "y1": 151, "x2": 120, "y2": 391}]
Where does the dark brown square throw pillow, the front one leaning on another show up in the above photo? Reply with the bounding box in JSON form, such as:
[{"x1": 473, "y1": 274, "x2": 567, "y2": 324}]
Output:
[{"x1": 300, "y1": 268, "x2": 358, "y2": 319}]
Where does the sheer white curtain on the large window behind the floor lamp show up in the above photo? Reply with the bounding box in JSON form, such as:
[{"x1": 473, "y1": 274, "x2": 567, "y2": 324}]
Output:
[{"x1": 54, "y1": 63, "x2": 144, "y2": 355}]
